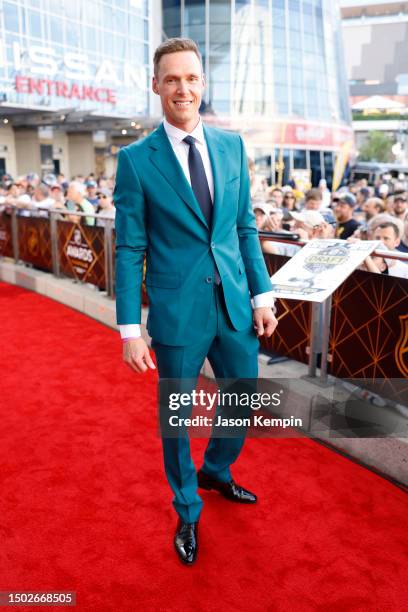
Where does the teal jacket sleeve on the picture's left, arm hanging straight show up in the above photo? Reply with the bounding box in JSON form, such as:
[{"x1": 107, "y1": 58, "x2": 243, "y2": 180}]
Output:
[{"x1": 114, "y1": 149, "x2": 147, "y2": 325}]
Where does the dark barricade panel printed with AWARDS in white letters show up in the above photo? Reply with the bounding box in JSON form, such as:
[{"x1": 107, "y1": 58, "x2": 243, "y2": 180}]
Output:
[{"x1": 57, "y1": 221, "x2": 106, "y2": 289}]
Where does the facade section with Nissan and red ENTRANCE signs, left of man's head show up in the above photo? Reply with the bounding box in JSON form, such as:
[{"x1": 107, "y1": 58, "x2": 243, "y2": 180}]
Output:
[{"x1": 0, "y1": 0, "x2": 152, "y2": 176}]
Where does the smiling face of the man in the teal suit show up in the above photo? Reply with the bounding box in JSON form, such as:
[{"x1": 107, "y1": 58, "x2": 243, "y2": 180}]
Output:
[{"x1": 152, "y1": 51, "x2": 205, "y2": 132}]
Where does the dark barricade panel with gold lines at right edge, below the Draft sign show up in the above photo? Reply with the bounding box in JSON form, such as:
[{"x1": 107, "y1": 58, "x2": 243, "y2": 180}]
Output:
[{"x1": 329, "y1": 264, "x2": 408, "y2": 401}]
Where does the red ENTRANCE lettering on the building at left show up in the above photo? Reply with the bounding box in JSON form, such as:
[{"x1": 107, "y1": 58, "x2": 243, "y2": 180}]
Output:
[{"x1": 16, "y1": 75, "x2": 116, "y2": 104}]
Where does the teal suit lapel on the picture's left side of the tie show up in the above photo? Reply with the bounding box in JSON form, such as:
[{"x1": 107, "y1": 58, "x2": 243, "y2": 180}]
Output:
[{"x1": 149, "y1": 124, "x2": 208, "y2": 228}]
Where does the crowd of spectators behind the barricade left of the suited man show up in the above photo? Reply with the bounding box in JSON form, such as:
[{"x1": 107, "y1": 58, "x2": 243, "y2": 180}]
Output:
[{"x1": 0, "y1": 173, "x2": 115, "y2": 227}]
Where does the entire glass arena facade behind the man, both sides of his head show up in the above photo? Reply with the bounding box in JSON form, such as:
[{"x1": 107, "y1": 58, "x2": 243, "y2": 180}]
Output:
[{"x1": 0, "y1": 0, "x2": 352, "y2": 184}]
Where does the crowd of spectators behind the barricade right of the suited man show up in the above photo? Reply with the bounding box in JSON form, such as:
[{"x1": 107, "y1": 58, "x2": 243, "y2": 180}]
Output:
[{"x1": 250, "y1": 166, "x2": 408, "y2": 278}]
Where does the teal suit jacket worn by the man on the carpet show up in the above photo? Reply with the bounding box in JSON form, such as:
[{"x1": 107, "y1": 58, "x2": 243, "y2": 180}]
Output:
[{"x1": 114, "y1": 124, "x2": 271, "y2": 346}]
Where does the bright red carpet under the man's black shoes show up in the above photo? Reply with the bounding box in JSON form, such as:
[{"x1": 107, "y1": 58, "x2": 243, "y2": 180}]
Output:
[{"x1": 0, "y1": 283, "x2": 408, "y2": 612}]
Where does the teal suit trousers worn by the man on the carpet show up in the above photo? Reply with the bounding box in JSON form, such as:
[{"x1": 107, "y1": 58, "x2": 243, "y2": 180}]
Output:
[{"x1": 152, "y1": 284, "x2": 259, "y2": 523}]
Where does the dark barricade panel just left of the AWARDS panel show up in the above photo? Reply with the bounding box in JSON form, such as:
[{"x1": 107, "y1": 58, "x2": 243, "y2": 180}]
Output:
[{"x1": 18, "y1": 217, "x2": 52, "y2": 272}]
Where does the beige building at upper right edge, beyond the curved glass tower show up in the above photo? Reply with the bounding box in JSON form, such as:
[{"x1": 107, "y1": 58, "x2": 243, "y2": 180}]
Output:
[{"x1": 341, "y1": 0, "x2": 408, "y2": 165}]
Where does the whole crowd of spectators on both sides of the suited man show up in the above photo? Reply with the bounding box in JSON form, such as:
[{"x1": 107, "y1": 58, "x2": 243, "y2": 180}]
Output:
[{"x1": 0, "y1": 164, "x2": 408, "y2": 278}]
